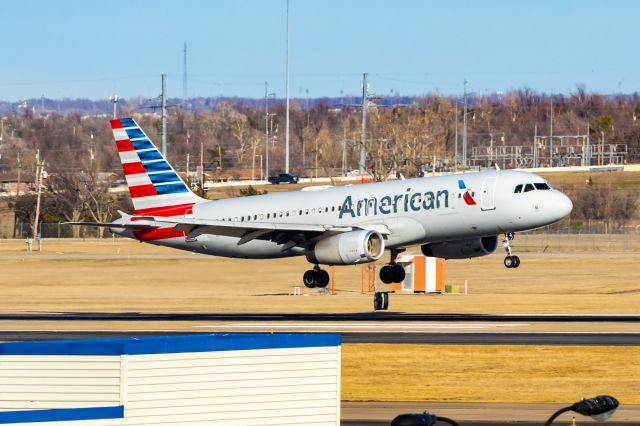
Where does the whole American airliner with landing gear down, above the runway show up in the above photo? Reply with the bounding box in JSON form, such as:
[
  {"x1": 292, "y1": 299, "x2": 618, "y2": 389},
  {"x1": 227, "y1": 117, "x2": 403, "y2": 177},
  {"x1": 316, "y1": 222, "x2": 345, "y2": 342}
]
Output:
[{"x1": 70, "y1": 118, "x2": 573, "y2": 288}]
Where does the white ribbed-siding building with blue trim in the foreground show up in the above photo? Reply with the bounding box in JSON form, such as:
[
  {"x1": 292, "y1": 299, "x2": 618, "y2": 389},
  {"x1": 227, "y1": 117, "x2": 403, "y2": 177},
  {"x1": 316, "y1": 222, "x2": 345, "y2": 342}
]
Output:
[{"x1": 0, "y1": 333, "x2": 340, "y2": 426}]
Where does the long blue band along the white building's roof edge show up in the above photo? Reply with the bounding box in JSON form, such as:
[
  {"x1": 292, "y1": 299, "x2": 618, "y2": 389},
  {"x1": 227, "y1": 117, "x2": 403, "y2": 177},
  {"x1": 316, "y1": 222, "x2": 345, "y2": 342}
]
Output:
[{"x1": 0, "y1": 333, "x2": 341, "y2": 356}]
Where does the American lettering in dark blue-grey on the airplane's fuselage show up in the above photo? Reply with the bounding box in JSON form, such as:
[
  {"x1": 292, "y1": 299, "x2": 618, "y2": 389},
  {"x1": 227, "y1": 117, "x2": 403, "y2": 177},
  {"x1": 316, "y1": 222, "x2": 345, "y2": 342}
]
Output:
[{"x1": 338, "y1": 188, "x2": 449, "y2": 219}]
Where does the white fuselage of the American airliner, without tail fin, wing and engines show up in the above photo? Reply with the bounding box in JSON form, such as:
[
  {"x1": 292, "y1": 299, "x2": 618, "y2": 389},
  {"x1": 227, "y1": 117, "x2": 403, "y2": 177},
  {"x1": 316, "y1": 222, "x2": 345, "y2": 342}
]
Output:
[{"x1": 116, "y1": 170, "x2": 572, "y2": 258}]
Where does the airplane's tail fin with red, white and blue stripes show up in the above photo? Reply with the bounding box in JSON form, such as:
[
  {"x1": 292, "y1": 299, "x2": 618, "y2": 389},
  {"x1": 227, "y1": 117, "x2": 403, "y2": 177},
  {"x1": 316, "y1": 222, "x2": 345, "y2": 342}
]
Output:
[{"x1": 111, "y1": 118, "x2": 204, "y2": 216}]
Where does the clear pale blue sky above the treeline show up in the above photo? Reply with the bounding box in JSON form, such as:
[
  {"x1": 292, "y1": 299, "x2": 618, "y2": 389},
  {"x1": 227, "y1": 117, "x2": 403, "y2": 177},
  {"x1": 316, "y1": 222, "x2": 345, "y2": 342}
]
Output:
[{"x1": 0, "y1": 0, "x2": 640, "y2": 101}]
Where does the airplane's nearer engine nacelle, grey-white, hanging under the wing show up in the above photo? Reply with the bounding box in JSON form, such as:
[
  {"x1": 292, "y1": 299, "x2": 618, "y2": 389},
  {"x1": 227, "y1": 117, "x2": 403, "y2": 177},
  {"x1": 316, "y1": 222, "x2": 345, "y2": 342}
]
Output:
[{"x1": 306, "y1": 230, "x2": 384, "y2": 265}]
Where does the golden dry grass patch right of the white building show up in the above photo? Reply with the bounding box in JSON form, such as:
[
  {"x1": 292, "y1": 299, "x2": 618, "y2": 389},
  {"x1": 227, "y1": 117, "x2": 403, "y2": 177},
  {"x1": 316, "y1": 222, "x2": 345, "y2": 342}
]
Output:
[{"x1": 342, "y1": 344, "x2": 640, "y2": 404}]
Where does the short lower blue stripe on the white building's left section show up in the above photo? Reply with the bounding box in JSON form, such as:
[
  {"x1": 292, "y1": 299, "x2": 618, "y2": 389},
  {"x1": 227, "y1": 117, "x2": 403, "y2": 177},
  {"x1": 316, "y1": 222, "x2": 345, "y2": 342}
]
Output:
[{"x1": 0, "y1": 405, "x2": 124, "y2": 424}]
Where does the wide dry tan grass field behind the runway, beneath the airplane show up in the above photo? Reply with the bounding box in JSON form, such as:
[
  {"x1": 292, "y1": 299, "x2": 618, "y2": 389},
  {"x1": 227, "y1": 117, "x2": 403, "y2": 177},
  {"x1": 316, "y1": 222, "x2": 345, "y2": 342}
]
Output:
[{"x1": 0, "y1": 240, "x2": 640, "y2": 313}]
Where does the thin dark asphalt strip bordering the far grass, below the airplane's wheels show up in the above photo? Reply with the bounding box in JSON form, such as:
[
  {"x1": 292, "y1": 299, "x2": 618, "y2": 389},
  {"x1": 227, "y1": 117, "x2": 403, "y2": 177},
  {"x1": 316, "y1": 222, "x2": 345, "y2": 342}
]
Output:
[{"x1": 0, "y1": 311, "x2": 640, "y2": 323}]
